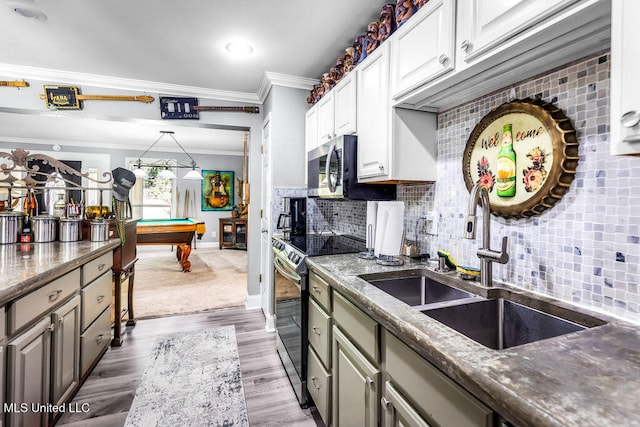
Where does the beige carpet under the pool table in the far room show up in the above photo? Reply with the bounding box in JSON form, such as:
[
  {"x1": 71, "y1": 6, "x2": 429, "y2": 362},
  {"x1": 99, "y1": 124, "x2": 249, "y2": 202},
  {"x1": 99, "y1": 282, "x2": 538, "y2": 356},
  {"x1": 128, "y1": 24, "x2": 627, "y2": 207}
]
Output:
[{"x1": 133, "y1": 246, "x2": 247, "y2": 318}]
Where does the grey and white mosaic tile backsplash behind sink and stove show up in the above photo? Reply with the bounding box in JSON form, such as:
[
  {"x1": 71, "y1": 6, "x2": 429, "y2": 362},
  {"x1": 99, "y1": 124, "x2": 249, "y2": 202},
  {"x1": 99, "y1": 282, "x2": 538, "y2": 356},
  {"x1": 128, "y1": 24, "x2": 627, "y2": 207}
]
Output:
[{"x1": 292, "y1": 52, "x2": 640, "y2": 323}]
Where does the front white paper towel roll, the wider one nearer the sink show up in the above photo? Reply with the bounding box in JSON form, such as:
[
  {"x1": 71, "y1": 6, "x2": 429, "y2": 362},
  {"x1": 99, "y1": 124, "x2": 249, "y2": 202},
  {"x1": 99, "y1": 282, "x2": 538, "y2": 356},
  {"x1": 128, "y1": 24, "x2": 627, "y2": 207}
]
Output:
[{"x1": 374, "y1": 201, "x2": 404, "y2": 256}]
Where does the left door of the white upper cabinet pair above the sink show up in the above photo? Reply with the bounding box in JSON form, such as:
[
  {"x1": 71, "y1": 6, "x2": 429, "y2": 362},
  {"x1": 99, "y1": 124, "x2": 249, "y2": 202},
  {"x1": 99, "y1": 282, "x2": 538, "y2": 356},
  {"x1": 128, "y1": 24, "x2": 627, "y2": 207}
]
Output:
[{"x1": 391, "y1": 0, "x2": 455, "y2": 98}]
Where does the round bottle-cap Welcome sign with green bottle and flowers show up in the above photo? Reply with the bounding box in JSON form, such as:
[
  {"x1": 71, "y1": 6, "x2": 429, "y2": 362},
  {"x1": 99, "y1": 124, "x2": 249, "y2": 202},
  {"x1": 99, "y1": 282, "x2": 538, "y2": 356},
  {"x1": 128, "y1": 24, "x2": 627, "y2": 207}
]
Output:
[{"x1": 462, "y1": 98, "x2": 578, "y2": 218}]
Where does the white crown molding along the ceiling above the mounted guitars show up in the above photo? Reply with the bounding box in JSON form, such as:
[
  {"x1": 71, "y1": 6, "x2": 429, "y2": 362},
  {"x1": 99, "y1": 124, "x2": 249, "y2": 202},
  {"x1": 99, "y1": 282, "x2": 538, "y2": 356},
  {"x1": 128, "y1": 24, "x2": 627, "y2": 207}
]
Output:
[{"x1": 0, "y1": 63, "x2": 261, "y2": 104}]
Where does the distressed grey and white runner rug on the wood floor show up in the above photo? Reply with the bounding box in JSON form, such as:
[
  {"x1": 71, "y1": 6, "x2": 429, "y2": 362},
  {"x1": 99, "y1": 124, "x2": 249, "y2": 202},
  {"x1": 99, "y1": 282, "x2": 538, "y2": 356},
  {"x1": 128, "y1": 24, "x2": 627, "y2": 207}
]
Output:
[{"x1": 125, "y1": 326, "x2": 249, "y2": 427}]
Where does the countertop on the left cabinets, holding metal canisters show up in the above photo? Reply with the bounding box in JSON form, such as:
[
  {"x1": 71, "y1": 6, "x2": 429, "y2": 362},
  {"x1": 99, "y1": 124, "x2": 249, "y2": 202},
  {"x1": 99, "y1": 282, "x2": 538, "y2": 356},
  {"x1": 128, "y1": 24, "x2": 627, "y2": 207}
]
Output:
[{"x1": 0, "y1": 239, "x2": 120, "y2": 305}]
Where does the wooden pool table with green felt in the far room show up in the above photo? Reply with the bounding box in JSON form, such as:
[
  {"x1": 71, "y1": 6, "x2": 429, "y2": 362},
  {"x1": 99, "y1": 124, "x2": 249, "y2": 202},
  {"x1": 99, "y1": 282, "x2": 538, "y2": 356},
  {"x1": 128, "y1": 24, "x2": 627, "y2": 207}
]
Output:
[{"x1": 136, "y1": 218, "x2": 206, "y2": 273}]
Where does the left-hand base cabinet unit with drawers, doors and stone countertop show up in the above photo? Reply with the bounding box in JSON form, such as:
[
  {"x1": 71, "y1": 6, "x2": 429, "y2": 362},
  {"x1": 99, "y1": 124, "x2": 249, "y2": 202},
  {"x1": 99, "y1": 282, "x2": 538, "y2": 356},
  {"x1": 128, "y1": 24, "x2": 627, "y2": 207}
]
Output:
[{"x1": 0, "y1": 239, "x2": 120, "y2": 425}]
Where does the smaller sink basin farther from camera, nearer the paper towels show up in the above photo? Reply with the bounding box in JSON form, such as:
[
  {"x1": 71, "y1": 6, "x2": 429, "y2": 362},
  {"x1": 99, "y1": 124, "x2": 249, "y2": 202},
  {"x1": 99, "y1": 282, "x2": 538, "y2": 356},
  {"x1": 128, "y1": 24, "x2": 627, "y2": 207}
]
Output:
[{"x1": 360, "y1": 271, "x2": 474, "y2": 307}]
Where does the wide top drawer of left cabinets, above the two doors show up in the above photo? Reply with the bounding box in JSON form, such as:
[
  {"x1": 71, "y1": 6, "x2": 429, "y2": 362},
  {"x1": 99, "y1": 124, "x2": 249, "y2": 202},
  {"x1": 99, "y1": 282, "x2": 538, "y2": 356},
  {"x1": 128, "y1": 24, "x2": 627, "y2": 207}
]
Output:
[{"x1": 7, "y1": 268, "x2": 80, "y2": 335}]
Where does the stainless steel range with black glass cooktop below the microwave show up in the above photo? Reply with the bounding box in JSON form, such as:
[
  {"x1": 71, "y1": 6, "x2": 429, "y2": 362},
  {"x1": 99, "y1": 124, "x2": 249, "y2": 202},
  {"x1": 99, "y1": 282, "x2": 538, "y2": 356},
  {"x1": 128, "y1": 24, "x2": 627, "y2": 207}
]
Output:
[{"x1": 272, "y1": 234, "x2": 365, "y2": 407}]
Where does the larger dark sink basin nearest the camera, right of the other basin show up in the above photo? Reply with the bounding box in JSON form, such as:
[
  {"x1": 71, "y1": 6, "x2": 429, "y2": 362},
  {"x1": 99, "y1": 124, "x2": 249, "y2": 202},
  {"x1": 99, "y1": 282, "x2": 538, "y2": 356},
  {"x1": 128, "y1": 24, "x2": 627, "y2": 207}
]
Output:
[{"x1": 422, "y1": 298, "x2": 586, "y2": 350}]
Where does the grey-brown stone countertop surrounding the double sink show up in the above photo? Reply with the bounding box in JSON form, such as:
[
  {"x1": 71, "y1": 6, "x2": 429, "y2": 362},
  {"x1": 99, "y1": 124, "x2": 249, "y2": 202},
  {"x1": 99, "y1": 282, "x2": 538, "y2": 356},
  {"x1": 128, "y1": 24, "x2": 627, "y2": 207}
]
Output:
[{"x1": 307, "y1": 254, "x2": 640, "y2": 427}]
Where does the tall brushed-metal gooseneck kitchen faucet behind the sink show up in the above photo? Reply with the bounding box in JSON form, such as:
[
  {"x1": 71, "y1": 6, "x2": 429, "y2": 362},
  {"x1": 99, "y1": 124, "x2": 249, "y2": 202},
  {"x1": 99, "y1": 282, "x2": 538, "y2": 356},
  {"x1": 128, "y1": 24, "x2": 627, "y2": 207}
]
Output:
[{"x1": 464, "y1": 183, "x2": 509, "y2": 287}]
